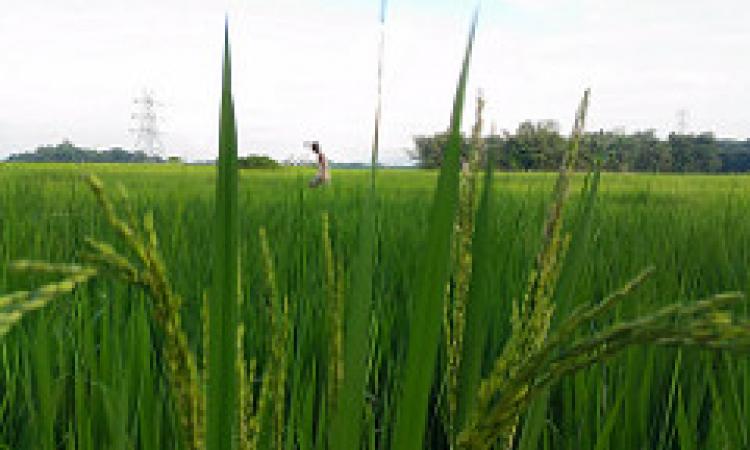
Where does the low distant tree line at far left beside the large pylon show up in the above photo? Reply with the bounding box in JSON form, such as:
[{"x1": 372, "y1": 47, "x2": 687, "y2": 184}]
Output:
[{"x1": 8, "y1": 140, "x2": 164, "y2": 163}]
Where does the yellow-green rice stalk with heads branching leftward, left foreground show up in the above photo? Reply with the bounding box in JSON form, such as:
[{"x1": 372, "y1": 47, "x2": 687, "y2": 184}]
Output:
[{"x1": 7, "y1": 171, "x2": 203, "y2": 450}]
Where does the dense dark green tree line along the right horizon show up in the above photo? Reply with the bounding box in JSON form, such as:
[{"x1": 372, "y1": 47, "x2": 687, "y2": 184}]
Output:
[{"x1": 410, "y1": 121, "x2": 750, "y2": 172}]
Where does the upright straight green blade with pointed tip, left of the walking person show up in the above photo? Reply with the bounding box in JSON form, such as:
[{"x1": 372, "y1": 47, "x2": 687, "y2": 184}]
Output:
[{"x1": 206, "y1": 24, "x2": 239, "y2": 450}]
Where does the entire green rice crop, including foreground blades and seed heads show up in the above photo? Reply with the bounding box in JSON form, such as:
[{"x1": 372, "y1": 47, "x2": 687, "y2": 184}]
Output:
[{"x1": 0, "y1": 4, "x2": 750, "y2": 450}]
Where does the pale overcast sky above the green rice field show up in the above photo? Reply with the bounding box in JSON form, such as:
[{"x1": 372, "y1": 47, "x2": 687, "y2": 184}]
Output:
[{"x1": 0, "y1": 0, "x2": 750, "y2": 162}]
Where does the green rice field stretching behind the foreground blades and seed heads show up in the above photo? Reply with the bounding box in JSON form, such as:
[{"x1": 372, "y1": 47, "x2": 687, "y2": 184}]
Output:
[{"x1": 0, "y1": 164, "x2": 750, "y2": 450}]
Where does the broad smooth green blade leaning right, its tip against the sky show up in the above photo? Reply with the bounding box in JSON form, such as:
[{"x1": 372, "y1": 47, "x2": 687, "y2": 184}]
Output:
[{"x1": 393, "y1": 14, "x2": 477, "y2": 450}]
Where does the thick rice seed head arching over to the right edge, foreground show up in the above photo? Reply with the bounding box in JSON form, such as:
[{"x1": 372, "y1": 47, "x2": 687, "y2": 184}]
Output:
[{"x1": 459, "y1": 278, "x2": 750, "y2": 449}]
